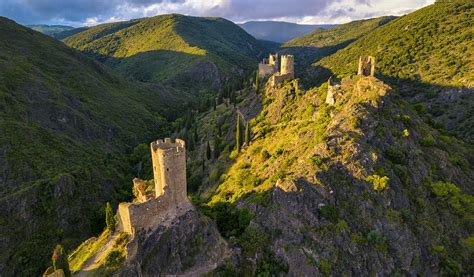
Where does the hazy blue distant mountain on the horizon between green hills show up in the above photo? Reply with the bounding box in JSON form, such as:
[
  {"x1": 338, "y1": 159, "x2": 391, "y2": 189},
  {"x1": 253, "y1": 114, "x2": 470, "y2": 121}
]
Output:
[{"x1": 239, "y1": 21, "x2": 337, "y2": 43}]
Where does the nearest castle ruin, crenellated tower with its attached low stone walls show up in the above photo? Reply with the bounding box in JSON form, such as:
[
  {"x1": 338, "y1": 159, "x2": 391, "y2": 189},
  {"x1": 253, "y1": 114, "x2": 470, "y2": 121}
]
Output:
[{"x1": 117, "y1": 138, "x2": 192, "y2": 235}]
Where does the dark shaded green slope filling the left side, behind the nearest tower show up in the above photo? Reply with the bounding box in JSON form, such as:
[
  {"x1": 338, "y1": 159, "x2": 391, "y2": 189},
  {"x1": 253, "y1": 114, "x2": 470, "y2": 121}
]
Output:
[{"x1": 0, "y1": 18, "x2": 188, "y2": 275}]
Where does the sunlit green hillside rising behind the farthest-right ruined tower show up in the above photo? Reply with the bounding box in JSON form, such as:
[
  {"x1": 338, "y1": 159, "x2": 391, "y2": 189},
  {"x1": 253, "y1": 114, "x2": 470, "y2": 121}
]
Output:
[{"x1": 315, "y1": 0, "x2": 474, "y2": 142}]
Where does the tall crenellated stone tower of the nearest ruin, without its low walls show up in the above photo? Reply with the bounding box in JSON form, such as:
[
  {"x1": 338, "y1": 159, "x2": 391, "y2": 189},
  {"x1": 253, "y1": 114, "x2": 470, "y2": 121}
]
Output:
[{"x1": 150, "y1": 138, "x2": 188, "y2": 206}]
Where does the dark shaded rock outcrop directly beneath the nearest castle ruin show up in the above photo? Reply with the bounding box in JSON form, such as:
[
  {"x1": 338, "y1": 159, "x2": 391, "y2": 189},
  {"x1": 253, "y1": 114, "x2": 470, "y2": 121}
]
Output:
[{"x1": 117, "y1": 209, "x2": 230, "y2": 276}]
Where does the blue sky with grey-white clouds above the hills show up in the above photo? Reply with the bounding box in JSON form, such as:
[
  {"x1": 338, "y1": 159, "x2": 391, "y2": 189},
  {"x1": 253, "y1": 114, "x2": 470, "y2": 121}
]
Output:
[{"x1": 0, "y1": 0, "x2": 435, "y2": 27}]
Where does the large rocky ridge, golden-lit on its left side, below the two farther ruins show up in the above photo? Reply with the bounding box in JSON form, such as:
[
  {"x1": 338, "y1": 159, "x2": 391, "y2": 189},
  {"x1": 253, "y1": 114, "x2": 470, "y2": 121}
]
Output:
[{"x1": 199, "y1": 77, "x2": 474, "y2": 275}]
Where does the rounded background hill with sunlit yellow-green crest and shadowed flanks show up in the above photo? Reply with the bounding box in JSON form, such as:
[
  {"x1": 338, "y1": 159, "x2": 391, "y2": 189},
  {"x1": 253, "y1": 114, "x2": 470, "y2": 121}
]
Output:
[{"x1": 64, "y1": 14, "x2": 263, "y2": 89}]
